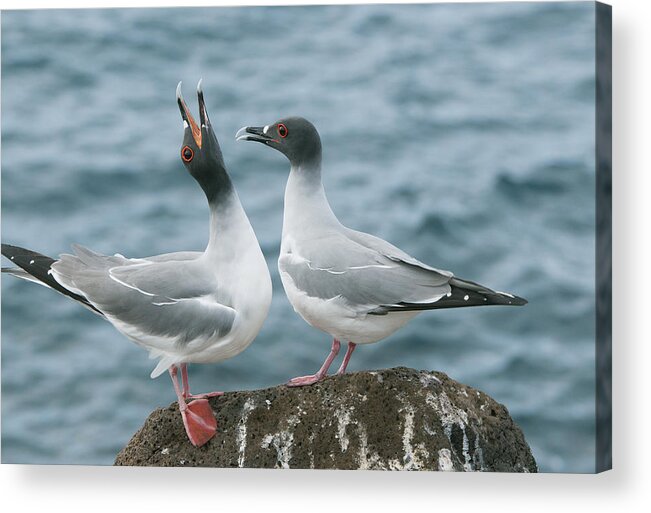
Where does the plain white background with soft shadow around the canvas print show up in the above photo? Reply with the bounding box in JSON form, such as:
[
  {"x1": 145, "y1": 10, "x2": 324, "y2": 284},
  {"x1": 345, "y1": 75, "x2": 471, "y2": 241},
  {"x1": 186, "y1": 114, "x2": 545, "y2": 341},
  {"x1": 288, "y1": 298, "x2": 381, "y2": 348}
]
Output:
[{"x1": 0, "y1": 0, "x2": 651, "y2": 513}]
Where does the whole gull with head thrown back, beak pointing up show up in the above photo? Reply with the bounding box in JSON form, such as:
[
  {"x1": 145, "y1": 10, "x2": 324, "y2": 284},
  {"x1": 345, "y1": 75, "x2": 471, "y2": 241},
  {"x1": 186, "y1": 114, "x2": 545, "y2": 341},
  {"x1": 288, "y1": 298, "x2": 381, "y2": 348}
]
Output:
[{"x1": 2, "y1": 82, "x2": 271, "y2": 446}]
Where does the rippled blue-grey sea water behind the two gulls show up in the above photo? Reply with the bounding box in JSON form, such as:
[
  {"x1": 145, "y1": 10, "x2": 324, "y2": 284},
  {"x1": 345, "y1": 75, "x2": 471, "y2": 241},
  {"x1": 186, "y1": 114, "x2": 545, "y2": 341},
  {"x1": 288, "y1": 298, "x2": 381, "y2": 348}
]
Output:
[{"x1": 2, "y1": 2, "x2": 595, "y2": 472}]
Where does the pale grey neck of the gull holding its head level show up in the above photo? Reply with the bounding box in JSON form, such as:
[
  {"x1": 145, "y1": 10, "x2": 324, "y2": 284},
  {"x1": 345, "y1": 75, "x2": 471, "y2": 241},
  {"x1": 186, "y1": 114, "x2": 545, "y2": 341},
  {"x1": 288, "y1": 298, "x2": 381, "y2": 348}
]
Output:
[{"x1": 283, "y1": 159, "x2": 341, "y2": 237}]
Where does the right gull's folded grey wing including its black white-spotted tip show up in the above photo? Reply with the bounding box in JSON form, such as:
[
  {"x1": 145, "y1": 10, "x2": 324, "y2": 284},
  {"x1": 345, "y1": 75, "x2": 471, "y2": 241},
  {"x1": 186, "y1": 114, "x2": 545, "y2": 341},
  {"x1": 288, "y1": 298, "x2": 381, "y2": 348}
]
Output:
[{"x1": 279, "y1": 229, "x2": 526, "y2": 315}]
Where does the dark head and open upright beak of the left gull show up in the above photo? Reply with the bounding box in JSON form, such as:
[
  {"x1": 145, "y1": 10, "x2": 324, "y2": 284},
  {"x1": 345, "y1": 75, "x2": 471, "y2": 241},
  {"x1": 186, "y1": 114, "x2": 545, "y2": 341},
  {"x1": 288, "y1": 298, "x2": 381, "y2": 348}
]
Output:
[{"x1": 176, "y1": 80, "x2": 233, "y2": 203}]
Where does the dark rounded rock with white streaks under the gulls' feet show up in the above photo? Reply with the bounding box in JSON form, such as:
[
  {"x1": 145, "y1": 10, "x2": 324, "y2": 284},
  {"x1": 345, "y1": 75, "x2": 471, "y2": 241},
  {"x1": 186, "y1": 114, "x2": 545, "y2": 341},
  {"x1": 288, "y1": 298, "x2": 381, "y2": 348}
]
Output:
[{"x1": 115, "y1": 367, "x2": 537, "y2": 472}]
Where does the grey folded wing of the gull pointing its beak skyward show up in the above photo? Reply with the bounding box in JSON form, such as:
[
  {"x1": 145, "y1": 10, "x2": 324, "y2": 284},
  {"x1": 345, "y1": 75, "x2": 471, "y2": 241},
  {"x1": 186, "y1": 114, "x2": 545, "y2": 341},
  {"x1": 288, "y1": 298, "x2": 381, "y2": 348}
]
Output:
[{"x1": 52, "y1": 246, "x2": 236, "y2": 344}]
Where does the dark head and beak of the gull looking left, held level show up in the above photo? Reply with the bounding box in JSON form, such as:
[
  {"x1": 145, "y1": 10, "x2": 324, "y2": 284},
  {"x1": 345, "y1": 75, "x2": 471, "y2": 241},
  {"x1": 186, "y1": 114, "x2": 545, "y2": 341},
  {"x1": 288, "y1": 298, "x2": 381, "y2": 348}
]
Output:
[{"x1": 236, "y1": 117, "x2": 321, "y2": 166}]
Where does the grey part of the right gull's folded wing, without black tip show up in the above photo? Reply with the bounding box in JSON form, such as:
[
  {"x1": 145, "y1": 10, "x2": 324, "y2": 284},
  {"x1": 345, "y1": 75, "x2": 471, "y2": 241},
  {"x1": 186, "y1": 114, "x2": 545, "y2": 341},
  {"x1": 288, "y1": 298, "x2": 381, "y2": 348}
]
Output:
[{"x1": 278, "y1": 230, "x2": 452, "y2": 313}]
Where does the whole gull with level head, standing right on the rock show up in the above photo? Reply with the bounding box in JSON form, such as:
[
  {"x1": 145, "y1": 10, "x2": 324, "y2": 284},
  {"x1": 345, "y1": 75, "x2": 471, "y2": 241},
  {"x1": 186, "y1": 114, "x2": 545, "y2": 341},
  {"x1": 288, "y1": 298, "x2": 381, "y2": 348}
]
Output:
[{"x1": 236, "y1": 117, "x2": 527, "y2": 386}]
